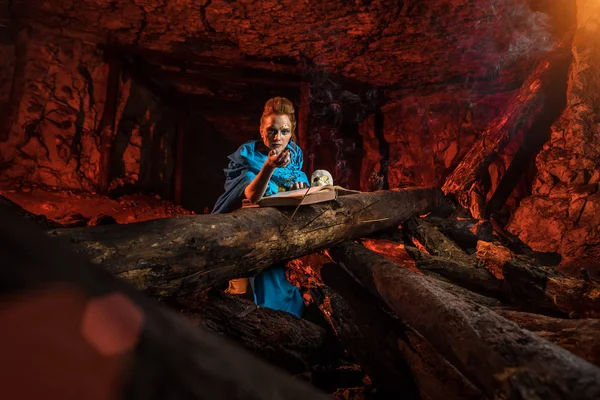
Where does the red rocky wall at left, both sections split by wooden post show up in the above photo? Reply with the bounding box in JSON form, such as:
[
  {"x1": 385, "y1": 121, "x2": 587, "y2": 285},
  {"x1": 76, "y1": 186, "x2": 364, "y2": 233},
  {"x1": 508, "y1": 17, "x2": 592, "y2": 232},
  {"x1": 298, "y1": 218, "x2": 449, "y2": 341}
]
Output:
[{"x1": 0, "y1": 29, "x2": 175, "y2": 198}]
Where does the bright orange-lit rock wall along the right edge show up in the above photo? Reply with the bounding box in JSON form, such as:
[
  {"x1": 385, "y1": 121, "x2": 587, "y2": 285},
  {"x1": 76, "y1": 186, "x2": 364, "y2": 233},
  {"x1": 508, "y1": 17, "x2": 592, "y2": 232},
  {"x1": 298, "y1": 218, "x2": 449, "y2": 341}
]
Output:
[{"x1": 509, "y1": 0, "x2": 600, "y2": 273}]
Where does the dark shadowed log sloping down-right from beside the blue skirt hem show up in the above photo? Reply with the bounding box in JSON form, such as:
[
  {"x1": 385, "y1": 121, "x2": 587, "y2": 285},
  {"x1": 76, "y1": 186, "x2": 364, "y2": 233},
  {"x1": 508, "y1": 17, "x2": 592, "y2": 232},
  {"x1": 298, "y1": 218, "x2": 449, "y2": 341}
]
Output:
[{"x1": 320, "y1": 263, "x2": 481, "y2": 400}]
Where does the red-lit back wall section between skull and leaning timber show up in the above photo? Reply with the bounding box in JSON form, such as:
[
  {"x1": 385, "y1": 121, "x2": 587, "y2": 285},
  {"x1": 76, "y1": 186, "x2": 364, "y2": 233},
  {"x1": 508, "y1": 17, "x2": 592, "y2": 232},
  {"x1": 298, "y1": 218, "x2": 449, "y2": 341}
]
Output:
[{"x1": 361, "y1": 92, "x2": 511, "y2": 190}]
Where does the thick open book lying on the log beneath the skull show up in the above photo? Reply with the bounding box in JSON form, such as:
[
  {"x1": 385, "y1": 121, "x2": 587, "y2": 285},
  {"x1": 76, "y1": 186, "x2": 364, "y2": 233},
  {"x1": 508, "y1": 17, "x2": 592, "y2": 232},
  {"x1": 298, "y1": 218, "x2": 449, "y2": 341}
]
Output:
[{"x1": 242, "y1": 185, "x2": 360, "y2": 208}]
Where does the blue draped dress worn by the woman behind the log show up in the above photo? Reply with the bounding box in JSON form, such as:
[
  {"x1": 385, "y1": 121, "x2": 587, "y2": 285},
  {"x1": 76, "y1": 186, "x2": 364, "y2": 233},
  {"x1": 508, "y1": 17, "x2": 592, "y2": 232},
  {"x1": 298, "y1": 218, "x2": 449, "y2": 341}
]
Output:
[{"x1": 212, "y1": 140, "x2": 308, "y2": 317}]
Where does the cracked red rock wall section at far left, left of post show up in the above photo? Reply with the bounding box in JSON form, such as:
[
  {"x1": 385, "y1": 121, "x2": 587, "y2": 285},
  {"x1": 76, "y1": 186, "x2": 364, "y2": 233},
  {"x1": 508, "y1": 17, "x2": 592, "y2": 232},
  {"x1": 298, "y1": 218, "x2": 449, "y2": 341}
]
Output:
[{"x1": 0, "y1": 32, "x2": 107, "y2": 190}]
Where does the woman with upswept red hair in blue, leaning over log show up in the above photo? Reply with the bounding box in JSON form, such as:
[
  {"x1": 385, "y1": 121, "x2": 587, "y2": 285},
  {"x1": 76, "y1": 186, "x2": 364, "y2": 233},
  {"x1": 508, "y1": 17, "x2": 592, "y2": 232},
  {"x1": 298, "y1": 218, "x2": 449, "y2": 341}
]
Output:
[{"x1": 213, "y1": 97, "x2": 308, "y2": 317}]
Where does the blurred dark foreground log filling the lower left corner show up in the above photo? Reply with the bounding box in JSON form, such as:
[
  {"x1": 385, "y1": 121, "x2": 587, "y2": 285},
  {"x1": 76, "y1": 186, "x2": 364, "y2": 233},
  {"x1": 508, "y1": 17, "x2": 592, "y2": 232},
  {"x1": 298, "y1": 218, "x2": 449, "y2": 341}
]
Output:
[{"x1": 0, "y1": 210, "x2": 327, "y2": 400}]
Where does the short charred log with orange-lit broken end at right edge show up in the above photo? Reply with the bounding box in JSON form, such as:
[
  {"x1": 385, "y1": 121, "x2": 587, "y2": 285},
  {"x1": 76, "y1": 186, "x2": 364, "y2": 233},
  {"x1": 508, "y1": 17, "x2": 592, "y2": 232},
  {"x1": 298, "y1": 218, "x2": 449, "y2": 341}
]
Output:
[{"x1": 476, "y1": 242, "x2": 600, "y2": 318}]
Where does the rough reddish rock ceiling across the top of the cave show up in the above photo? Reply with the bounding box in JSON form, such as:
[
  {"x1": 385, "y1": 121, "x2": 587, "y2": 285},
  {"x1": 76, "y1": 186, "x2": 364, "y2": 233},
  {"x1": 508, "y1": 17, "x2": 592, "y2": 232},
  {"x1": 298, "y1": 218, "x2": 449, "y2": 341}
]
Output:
[{"x1": 12, "y1": 0, "x2": 564, "y2": 88}]
